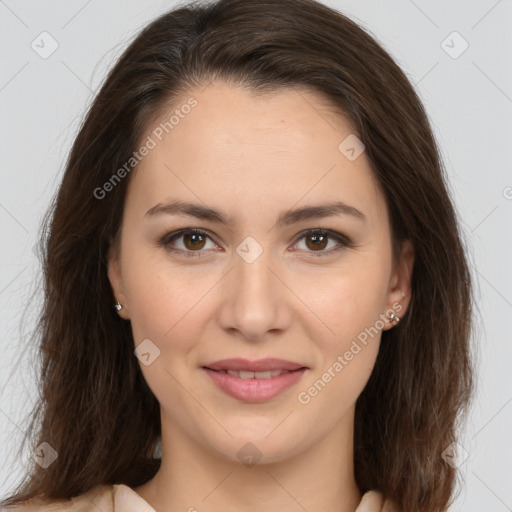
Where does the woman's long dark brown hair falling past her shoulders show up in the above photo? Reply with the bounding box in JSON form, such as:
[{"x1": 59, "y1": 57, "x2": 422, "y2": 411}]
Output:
[{"x1": 2, "y1": 0, "x2": 475, "y2": 512}]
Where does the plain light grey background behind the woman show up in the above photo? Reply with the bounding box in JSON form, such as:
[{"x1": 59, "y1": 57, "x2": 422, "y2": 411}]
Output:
[{"x1": 0, "y1": 0, "x2": 512, "y2": 512}]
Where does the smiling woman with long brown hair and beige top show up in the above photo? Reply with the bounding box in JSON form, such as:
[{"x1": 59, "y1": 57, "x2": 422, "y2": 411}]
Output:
[{"x1": 3, "y1": 0, "x2": 473, "y2": 512}]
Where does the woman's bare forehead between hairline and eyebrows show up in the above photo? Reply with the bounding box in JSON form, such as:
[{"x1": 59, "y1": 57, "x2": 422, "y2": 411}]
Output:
[{"x1": 127, "y1": 82, "x2": 386, "y2": 229}]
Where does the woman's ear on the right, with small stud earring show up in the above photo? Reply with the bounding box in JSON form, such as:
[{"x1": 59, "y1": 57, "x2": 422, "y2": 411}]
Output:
[{"x1": 383, "y1": 239, "x2": 414, "y2": 330}]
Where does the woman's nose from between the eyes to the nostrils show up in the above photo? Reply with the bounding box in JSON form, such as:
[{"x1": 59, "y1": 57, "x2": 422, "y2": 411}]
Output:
[{"x1": 218, "y1": 242, "x2": 293, "y2": 341}]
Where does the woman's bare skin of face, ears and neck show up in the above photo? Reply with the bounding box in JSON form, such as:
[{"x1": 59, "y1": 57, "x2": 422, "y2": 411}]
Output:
[{"x1": 108, "y1": 82, "x2": 414, "y2": 512}]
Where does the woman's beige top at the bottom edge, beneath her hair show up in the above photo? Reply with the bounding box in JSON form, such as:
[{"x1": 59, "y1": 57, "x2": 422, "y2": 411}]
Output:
[{"x1": 8, "y1": 484, "x2": 396, "y2": 512}]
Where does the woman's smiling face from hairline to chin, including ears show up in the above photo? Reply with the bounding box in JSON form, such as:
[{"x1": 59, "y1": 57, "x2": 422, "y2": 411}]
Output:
[{"x1": 109, "y1": 82, "x2": 412, "y2": 462}]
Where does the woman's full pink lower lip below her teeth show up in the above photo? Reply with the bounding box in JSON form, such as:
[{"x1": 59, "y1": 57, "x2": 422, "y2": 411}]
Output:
[{"x1": 203, "y1": 368, "x2": 306, "y2": 402}]
